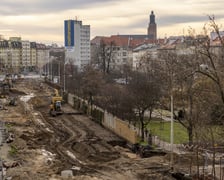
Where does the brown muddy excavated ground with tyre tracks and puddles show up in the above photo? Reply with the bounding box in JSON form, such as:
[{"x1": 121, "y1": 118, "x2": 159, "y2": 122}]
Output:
[{"x1": 0, "y1": 79, "x2": 173, "y2": 180}]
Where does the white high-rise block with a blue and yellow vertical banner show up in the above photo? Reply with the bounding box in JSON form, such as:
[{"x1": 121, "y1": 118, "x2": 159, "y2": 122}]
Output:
[{"x1": 64, "y1": 20, "x2": 90, "y2": 69}]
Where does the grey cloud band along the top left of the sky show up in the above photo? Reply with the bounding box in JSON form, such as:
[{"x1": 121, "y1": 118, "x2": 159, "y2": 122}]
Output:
[{"x1": 0, "y1": 0, "x2": 124, "y2": 15}]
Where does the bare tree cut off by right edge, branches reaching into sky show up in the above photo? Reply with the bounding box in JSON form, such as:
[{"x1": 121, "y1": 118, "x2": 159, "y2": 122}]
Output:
[{"x1": 192, "y1": 16, "x2": 224, "y2": 129}]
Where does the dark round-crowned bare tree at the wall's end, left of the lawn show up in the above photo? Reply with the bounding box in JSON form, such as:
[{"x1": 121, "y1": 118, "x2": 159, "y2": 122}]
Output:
[{"x1": 127, "y1": 72, "x2": 161, "y2": 141}]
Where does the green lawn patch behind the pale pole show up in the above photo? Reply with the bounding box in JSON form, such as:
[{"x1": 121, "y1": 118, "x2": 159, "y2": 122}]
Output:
[{"x1": 148, "y1": 120, "x2": 188, "y2": 144}]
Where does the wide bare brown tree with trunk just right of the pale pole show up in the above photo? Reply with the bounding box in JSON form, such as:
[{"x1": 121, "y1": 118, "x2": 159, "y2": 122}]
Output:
[{"x1": 160, "y1": 47, "x2": 206, "y2": 144}]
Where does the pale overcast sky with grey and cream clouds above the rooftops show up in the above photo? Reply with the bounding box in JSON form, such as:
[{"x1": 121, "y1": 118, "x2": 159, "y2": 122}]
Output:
[{"x1": 0, "y1": 0, "x2": 224, "y2": 45}]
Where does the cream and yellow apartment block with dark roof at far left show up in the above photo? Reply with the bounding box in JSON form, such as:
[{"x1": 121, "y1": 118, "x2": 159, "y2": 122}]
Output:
[{"x1": 0, "y1": 37, "x2": 49, "y2": 73}]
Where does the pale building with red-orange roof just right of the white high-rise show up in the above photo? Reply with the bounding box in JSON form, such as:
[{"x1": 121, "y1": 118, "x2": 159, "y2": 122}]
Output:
[{"x1": 91, "y1": 35, "x2": 159, "y2": 72}]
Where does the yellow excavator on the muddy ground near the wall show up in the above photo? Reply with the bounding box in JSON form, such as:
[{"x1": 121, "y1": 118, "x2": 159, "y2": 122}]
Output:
[{"x1": 50, "y1": 89, "x2": 63, "y2": 116}]
